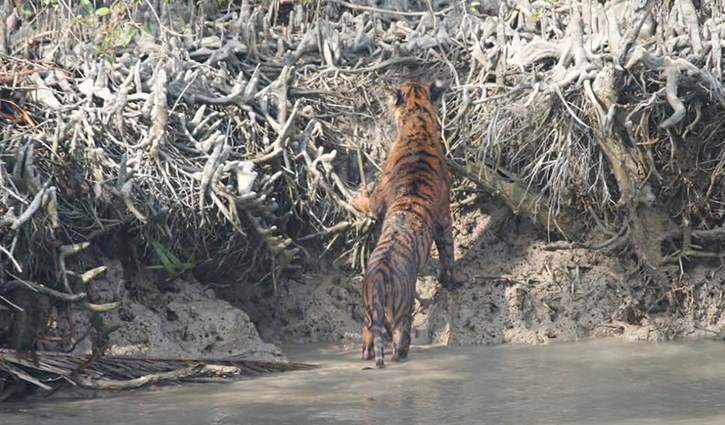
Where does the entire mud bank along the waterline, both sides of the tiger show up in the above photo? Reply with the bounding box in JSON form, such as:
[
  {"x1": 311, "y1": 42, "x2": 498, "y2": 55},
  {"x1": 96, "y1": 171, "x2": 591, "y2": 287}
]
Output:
[{"x1": 45, "y1": 199, "x2": 725, "y2": 361}]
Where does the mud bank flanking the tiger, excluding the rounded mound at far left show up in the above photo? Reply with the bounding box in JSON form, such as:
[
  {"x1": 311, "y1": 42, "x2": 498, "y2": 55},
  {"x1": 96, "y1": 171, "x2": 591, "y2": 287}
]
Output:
[{"x1": 226, "y1": 200, "x2": 725, "y2": 349}]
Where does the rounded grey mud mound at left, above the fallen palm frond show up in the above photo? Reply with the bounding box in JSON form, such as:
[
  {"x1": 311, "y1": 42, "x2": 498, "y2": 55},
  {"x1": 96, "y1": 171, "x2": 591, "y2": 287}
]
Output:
[{"x1": 52, "y1": 260, "x2": 286, "y2": 361}]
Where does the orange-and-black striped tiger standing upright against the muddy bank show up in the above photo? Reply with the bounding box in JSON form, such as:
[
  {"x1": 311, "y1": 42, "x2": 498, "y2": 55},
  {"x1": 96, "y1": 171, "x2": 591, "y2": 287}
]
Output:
[{"x1": 352, "y1": 79, "x2": 459, "y2": 368}]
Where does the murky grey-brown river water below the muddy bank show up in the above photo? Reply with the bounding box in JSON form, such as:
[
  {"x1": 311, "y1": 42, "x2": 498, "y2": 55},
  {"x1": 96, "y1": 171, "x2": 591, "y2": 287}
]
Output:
[{"x1": 0, "y1": 340, "x2": 725, "y2": 425}]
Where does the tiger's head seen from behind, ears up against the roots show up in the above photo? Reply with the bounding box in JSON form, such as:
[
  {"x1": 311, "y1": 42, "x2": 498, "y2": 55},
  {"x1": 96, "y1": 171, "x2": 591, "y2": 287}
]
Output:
[{"x1": 390, "y1": 79, "x2": 448, "y2": 128}]
